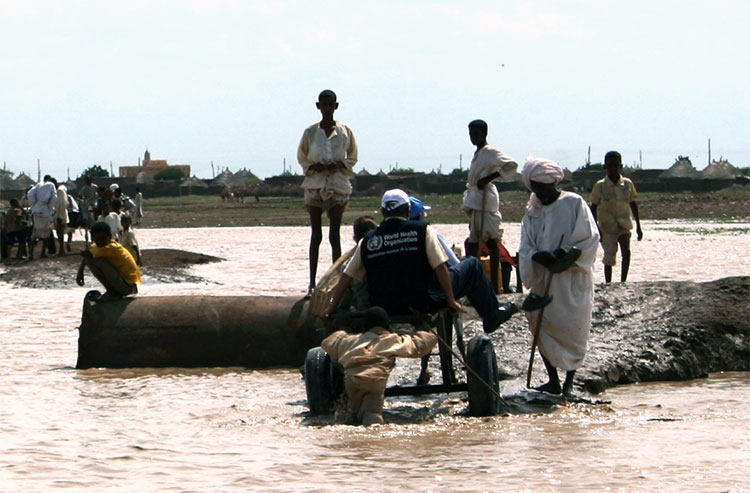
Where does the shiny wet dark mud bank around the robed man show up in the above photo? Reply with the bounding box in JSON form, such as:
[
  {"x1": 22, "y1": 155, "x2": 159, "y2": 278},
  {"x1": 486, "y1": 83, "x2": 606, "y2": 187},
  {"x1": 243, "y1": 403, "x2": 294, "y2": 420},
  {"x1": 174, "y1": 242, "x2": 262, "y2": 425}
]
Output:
[{"x1": 492, "y1": 276, "x2": 750, "y2": 394}]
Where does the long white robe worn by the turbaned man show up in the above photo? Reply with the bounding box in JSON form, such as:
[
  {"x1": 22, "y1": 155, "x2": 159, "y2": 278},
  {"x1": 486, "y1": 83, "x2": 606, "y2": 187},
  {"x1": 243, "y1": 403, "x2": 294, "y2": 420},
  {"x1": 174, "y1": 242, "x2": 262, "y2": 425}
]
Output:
[{"x1": 519, "y1": 192, "x2": 599, "y2": 371}]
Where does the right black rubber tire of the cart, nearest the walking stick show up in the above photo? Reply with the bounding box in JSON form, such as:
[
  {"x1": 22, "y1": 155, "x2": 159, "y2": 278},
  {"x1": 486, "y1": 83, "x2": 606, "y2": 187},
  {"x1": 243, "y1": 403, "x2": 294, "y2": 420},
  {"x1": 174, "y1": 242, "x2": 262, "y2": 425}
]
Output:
[{"x1": 466, "y1": 335, "x2": 500, "y2": 416}]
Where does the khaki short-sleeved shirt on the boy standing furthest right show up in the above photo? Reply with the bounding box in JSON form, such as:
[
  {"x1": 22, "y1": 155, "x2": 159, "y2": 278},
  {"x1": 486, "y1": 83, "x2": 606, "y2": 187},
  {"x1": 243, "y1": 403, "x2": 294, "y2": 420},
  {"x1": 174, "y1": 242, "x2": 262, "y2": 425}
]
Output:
[{"x1": 591, "y1": 176, "x2": 637, "y2": 234}]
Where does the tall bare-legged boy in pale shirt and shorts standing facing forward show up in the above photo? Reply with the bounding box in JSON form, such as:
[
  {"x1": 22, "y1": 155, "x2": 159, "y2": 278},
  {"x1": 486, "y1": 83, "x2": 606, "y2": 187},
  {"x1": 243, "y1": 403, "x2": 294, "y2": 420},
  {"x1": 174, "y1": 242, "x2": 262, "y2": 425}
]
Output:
[{"x1": 297, "y1": 89, "x2": 357, "y2": 298}]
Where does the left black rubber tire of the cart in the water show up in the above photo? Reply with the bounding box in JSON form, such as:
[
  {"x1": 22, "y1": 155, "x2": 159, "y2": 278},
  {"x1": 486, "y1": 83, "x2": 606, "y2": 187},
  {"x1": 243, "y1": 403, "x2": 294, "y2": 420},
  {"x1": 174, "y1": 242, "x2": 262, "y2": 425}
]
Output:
[{"x1": 305, "y1": 347, "x2": 344, "y2": 415}]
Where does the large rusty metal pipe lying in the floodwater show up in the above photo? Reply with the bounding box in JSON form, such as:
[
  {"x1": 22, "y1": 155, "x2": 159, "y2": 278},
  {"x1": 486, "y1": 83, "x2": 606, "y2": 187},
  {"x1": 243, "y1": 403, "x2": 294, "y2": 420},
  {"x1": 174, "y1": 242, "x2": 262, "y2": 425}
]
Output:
[{"x1": 76, "y1": 295, "x2": 323, "y2": 368}]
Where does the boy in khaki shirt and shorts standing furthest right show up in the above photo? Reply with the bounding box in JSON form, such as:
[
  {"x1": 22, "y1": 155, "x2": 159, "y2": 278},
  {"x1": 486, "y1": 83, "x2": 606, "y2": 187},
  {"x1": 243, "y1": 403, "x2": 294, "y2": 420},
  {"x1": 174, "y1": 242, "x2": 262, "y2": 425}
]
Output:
[{"x1": 591, "y1": 151, "x2": 643, "y2": 282}]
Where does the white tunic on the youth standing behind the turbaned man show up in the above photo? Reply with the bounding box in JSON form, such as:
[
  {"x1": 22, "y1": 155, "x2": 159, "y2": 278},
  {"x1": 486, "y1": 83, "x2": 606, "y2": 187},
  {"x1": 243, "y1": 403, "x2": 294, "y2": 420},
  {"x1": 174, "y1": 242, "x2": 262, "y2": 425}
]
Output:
[{"x1": 463, "y1": 145, "x2": 518, "y2": 212}]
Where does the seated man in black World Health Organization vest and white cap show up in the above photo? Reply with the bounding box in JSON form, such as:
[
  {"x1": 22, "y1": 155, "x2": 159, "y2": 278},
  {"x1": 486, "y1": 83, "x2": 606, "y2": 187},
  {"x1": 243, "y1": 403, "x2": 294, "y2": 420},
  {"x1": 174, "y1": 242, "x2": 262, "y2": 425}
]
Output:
[{"x1": 324, "y1": 189, "x2": 549, "y2": 333}]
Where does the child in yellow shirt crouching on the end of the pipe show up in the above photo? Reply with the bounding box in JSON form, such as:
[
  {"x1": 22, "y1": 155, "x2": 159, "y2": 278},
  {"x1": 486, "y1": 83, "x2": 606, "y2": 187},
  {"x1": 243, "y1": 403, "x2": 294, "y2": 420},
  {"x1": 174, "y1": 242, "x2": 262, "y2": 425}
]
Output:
[{"x1": 76, "y1": 222, "x2": 141, "y2": 303}]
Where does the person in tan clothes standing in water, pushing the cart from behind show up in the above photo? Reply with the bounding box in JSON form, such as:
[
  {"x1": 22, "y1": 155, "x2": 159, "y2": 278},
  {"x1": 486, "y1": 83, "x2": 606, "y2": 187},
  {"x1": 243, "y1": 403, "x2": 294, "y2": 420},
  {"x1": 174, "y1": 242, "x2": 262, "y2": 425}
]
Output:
[{"x1": 320, "y1": 306, "x2": 437, "y2": 426}]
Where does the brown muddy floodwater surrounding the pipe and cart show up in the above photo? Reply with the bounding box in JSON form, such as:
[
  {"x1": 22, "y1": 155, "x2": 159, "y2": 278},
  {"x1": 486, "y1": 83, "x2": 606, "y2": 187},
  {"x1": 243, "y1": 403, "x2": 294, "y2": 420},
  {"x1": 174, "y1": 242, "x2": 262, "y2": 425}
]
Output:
[{"x1": 0, "y1": 221, "x2": 750, "y2": 492}]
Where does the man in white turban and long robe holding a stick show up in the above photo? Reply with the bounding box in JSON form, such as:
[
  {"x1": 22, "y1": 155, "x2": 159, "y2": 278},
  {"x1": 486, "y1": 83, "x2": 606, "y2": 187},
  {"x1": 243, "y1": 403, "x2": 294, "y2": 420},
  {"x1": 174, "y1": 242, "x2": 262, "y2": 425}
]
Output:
[{"x1": 519, "y1": 158, "x2": 599, "y2": 394}]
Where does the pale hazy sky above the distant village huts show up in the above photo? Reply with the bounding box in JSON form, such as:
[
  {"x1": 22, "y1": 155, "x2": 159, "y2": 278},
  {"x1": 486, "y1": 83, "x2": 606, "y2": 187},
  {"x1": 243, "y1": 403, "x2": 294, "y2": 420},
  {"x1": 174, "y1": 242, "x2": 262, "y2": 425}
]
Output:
[{"x1": 0, "y1": 0, "x2": 750, "y2": 179}]
